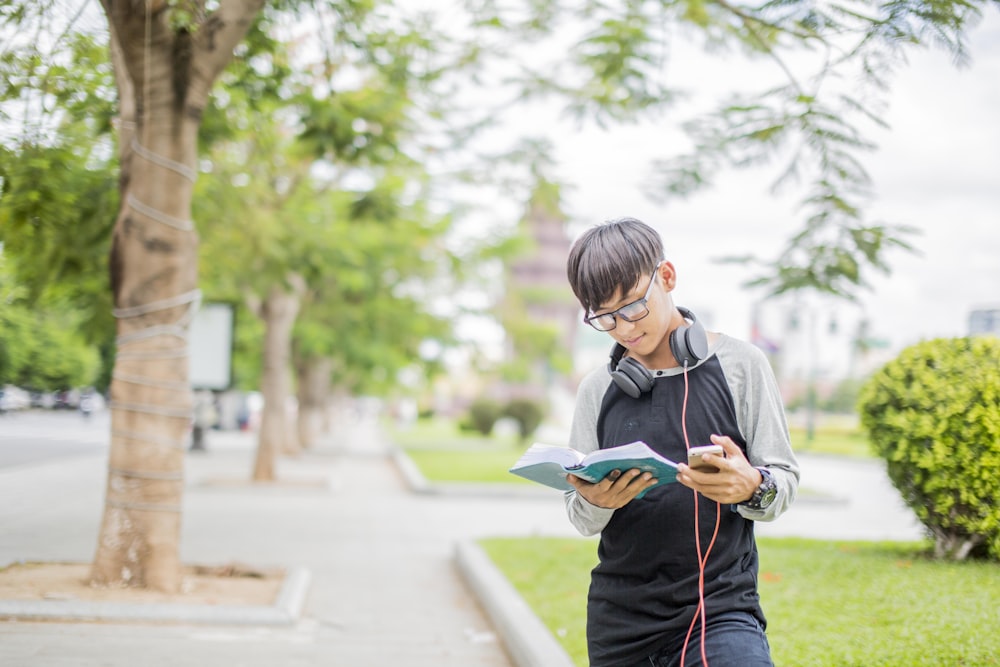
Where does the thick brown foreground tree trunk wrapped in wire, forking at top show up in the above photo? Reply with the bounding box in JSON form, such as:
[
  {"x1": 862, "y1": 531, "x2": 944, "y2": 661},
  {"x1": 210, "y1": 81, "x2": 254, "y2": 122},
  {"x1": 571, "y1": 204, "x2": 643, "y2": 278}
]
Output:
[{"x1": 91, "y1": 0, "x2": 263, "y2": 592}]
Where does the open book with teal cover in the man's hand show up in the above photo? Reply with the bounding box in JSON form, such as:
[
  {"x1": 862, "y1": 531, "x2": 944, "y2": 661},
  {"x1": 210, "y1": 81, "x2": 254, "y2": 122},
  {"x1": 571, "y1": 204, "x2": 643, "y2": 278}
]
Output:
[{"x1": 510, "y1": 441, "x2": 677, "y2": 498}]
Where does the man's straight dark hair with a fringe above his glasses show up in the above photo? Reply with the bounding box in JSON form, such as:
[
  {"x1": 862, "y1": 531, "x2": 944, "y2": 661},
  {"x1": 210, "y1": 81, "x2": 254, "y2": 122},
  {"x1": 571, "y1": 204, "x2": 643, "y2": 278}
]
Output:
[{"x1": 566, "y1": 218, "x2": 663, "y2": 313}]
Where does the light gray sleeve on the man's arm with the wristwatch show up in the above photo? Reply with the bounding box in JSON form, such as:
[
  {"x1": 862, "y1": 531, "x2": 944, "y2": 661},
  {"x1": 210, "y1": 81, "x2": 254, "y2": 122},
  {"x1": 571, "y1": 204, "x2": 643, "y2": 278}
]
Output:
[{"x1": 716, "y1": 336, "x2": 799, "y2": 521}]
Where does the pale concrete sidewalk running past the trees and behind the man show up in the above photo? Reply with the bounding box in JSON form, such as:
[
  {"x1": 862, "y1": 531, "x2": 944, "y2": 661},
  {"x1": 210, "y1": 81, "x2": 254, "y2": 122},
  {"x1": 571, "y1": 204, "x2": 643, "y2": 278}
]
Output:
[{"x1": 0, "y1": 414, "x2": 921, "y2": 667}]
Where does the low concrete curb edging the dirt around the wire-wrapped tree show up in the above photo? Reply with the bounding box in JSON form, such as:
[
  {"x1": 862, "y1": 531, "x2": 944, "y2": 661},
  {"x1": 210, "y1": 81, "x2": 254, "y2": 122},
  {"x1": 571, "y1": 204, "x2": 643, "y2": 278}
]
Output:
[{"x1": 0, "y1": 568, "x2": 312, "y2": 625}]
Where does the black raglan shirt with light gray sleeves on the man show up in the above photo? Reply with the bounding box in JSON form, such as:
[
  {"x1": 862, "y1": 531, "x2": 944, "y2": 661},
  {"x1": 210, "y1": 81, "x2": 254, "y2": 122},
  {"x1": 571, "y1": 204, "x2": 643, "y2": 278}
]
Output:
[{"x1": 566, "y1": 335, "x2": 799, "y2": 667}]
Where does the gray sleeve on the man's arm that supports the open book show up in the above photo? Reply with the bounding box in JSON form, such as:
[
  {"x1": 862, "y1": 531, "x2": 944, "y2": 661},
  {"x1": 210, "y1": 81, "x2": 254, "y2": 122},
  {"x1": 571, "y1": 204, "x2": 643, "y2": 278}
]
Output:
[{"x1": 565, "y1": 367, "x2": 615, "y2": 536}]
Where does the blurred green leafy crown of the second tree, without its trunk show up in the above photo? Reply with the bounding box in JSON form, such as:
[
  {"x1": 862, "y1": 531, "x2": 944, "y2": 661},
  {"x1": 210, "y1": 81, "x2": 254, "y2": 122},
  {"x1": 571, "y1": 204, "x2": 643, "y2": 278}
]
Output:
[{"x1": 194, "y1": 35, "x2": 454, "y2": 393}]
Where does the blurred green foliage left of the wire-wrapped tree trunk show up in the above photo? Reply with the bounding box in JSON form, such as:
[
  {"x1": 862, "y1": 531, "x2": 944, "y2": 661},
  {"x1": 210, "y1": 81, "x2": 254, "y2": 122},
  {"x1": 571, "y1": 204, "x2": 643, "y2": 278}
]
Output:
[{"x1": 0, "y1": 28, "x2": 118, "y2": 389}]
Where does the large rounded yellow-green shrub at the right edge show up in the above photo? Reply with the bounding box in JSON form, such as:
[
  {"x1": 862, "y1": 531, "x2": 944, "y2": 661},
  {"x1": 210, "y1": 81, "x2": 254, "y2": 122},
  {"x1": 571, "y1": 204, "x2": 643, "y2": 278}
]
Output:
[{"x1": 859, "y1": 337, "x2": 1000, "y2": 560}]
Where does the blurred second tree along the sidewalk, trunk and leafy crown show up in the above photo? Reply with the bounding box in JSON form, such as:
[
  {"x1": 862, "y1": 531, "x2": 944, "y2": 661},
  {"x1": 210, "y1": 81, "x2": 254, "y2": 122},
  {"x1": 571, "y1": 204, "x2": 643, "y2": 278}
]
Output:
[{"x1": 195, "y1": 15, "x2": 468, "y2": 472}]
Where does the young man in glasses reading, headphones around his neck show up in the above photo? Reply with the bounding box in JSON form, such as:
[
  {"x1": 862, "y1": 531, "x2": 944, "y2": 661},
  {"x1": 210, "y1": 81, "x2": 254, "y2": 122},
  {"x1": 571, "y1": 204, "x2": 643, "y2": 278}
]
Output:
[{"x1": 566, "y1": 218, "x2": 799, "y2": 667}]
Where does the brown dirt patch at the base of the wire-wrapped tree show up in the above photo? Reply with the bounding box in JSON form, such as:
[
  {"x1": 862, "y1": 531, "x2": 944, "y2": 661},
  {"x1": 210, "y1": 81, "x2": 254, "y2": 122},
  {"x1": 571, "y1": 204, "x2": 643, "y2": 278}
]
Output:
[{"x1": 0, "y1": 563, "x2": 285, "y2": 606}]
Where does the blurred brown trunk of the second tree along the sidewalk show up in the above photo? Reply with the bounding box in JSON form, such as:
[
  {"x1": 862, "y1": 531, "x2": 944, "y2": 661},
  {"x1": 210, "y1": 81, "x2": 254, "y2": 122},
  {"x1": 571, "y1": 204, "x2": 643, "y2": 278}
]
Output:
[{"x1": 253, "y1": 276, "x2": 305, "y2": 482}]
